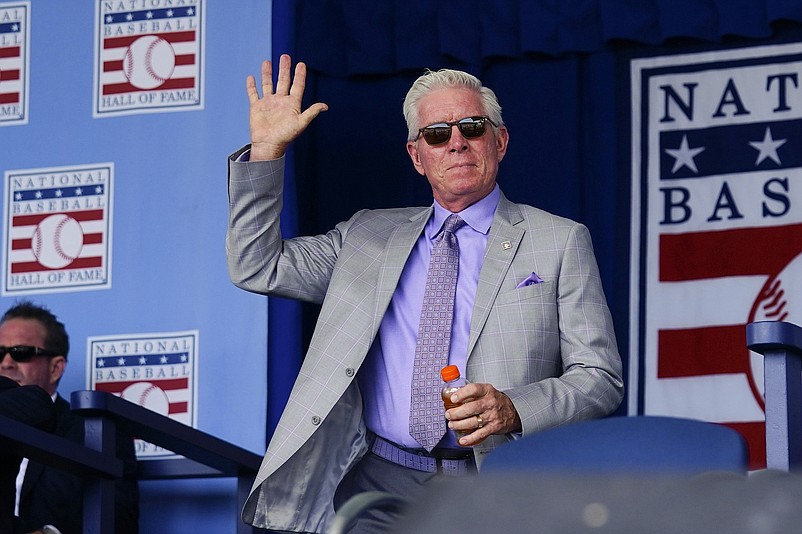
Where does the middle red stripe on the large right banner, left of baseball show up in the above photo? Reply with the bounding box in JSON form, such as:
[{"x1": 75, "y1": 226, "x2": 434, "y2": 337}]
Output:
[{"x1": 657, "y1": 324, "x2": 749, "y2": 378}]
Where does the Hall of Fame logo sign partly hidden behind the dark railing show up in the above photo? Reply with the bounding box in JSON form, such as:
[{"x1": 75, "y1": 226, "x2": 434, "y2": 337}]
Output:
[{"x1": 87, "y1": 330, "x2": 198, "y2": 459}]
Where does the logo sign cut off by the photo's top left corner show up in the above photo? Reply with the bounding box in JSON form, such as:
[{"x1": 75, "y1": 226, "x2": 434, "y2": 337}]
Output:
[{"x1": 0, "y1": 2, "x2": 31, "y2": 126}]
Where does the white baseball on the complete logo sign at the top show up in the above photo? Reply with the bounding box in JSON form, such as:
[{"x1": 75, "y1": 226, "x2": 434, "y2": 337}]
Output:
[{"x1": 123, "y1": 35, "x2": 175, "y2": 89}]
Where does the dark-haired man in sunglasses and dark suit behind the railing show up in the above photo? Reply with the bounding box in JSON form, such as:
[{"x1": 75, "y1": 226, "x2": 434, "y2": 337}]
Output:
[{"x1": 0, "y1": 301, "x2": 139, "y2": 534}]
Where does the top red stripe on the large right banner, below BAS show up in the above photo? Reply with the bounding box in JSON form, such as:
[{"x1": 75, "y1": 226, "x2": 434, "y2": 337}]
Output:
[{"x1": 660, "y1": 224, "x2": 802, "y2": 282}]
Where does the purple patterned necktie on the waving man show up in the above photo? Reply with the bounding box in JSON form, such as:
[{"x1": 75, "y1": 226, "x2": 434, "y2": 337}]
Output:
[{"x1": 409, "y1": 215, "x2": 465, "y2": 451}]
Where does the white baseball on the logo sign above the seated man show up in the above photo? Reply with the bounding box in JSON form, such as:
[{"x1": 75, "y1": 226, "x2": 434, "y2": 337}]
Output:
[{"x1": 31, "y1": 213, "x2": 84, "y2": 269}]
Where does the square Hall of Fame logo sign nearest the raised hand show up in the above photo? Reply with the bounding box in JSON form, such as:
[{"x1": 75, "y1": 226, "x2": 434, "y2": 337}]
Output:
[{"x1": 92, "y1": 0, "x2": 206, "y2": 118}]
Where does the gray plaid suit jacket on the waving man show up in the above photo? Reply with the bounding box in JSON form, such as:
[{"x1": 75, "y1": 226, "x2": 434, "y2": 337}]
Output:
[{"x1": 226, "y1": 147, "x2": 623, "y2": 532}]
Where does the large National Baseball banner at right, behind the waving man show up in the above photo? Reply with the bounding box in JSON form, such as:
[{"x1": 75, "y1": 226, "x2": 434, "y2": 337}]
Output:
[{"x1": 629, "y1": 43, "x2": 802, "y2": 469}]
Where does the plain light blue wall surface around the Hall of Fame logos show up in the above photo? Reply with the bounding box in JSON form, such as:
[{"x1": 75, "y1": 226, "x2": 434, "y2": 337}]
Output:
[{"x1": 0, "y1": 0, "x2": 271, "y2": 533}]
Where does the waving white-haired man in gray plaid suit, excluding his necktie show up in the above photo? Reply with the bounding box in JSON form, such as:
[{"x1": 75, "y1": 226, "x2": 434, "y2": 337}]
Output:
[{"x1": 226, "y1": 55, "x2": 623, "y2": 532}]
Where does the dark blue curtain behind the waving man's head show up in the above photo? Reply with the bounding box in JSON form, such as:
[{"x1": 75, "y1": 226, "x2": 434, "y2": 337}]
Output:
[{"x1": 269, "y1": 0, "x2": 802, "y2": 428}]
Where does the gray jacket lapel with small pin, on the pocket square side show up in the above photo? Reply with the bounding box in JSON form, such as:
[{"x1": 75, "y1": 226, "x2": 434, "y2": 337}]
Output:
[{"x1": 468, "y1": 193, "x2": 525, "y2": 358}]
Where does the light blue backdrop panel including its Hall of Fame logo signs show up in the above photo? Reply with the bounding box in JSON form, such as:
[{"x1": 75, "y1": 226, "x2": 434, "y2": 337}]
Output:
[{"x1": 0, "y1": 0, "x2": 271, "y2": 533}]
